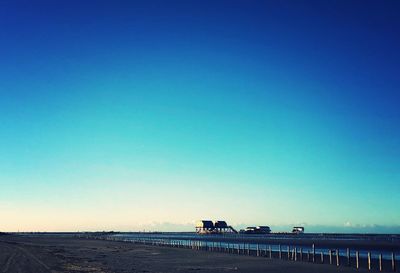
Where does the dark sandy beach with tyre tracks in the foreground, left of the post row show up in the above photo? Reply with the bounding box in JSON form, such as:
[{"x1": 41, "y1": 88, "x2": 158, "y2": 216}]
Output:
[{"x1": 0, "y1": 235, "x2": 378, "y2": 273}]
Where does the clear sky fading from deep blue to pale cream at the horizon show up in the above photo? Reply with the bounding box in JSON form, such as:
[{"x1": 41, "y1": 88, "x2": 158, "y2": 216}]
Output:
[{"x1": 0, "y1": 0, "x2": 400, "y2": 232}]
